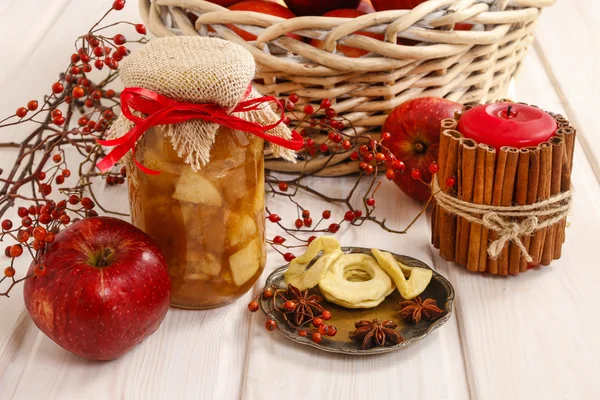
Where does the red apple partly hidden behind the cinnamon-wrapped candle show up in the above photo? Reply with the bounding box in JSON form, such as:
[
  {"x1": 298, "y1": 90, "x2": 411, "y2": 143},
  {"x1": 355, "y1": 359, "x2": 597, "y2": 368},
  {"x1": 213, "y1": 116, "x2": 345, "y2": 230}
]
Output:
[{"x1": 383, "y1": 97, "x2": 462, "y2": 201}]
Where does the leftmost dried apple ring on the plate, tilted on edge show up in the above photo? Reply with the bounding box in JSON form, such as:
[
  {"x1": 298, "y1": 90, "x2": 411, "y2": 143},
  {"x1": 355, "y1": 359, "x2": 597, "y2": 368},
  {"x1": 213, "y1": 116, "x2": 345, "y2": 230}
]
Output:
[{"x1": 285, "y1": 236, "x2": 343, "y2": 290}]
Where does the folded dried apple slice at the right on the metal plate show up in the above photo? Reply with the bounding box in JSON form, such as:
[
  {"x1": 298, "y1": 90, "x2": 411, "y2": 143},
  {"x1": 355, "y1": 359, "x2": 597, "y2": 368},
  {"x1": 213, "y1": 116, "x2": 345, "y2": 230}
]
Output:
[{"x1": 371, "y1": 249, "x2": 433, "y2": 300}]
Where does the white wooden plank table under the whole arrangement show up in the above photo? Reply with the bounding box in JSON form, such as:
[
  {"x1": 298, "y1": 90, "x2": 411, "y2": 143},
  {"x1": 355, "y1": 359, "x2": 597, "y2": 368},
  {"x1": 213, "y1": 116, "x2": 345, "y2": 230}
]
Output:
[{"x1": 0, "y1": 0, "x2": 600, "y2": 400}]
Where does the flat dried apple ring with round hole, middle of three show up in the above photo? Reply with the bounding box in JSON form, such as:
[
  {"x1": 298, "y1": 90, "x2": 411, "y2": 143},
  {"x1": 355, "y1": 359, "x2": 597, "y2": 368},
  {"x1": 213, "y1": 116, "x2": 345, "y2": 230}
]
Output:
[{"x1": 319, "y1": 254, "x2": 394, "y2": 308}]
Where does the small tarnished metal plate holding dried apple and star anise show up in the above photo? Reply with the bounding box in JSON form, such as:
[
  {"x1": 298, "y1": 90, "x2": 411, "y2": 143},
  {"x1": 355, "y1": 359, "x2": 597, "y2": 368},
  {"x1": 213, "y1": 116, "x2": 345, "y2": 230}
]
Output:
[{"x1": 259, "y1": 247, "x2": 454, "y2": 355}]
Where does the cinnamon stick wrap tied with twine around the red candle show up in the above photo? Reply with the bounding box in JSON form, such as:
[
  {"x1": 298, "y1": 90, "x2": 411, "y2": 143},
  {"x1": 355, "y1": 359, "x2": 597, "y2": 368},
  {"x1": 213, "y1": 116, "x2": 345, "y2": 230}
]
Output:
[{"x1": 431, "y1": 104, "x2": 576, "y2": 276}]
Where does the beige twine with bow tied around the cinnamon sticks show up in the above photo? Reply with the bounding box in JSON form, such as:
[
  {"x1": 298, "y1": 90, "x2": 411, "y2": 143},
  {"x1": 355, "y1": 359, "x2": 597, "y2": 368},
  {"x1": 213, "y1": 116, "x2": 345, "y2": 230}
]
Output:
[{"x1": 431, "y1": 175, "x2": 572, "y2": 263}]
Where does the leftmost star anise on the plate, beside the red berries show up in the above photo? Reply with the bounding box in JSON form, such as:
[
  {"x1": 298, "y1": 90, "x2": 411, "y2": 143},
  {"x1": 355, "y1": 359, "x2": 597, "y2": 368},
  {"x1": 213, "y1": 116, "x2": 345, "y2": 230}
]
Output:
[{"x1": 277, "y1": 285, "x2": 325, "y2": 328}]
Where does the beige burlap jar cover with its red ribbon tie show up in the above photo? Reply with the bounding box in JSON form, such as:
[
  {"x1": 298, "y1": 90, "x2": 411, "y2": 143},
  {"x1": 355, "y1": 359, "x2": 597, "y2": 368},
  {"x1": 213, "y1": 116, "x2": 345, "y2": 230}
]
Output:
[{"x1": 98, "y1": 36, "x2": 302, "y2": 172}]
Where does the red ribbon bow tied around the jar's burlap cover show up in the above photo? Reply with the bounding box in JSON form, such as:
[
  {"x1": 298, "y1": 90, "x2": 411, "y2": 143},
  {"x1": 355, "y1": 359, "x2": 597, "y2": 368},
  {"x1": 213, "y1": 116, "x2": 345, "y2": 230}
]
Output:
[{"x1": 97, "y1": 88, "x2": 304, "y2": 175}]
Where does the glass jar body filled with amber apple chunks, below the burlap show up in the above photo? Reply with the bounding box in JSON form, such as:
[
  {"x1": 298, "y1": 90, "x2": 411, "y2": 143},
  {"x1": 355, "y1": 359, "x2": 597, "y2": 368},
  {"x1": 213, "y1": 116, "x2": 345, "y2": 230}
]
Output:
[{"x1": 127, "y1": 126, "x2": 266, "y2": 309}]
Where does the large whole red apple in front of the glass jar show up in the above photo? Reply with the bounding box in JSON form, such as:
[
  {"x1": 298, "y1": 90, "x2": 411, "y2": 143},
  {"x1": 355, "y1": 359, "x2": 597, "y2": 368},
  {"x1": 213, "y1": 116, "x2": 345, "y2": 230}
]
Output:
[{"x1": 23, "y1": 217, "x2": 171, "y2": 360}]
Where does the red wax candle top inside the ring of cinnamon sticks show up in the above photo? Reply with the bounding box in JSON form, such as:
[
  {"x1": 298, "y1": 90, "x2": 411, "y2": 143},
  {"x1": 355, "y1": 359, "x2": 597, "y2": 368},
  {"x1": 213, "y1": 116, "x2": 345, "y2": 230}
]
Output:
[{"x1": 458, "y1": 103, "x2": 557, "y2": 150}]
